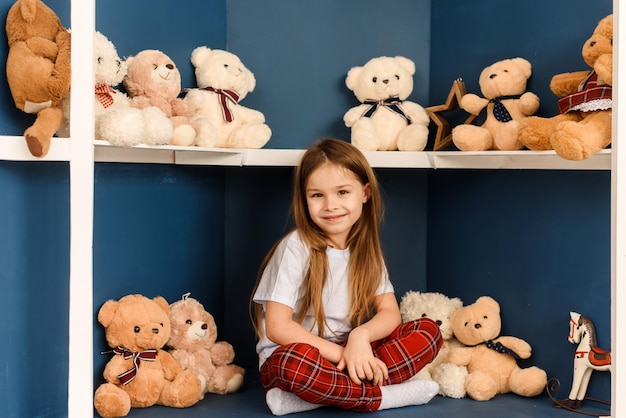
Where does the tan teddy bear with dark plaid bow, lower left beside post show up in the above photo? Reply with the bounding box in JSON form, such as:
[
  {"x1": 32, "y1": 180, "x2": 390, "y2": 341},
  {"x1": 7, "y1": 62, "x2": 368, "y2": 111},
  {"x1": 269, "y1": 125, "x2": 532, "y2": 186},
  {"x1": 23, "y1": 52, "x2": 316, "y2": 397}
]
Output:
[{"x1": 94, "y1": 294, "x2": 205, "y2": 418}]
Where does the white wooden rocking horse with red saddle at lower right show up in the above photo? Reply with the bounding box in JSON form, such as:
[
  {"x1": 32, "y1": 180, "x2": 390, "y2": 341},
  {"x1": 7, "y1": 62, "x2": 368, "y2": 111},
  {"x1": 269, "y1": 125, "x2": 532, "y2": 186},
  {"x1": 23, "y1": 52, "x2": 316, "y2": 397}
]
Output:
[{"x1": 548, "y1": 312, "x2": 611, "y2": 416}]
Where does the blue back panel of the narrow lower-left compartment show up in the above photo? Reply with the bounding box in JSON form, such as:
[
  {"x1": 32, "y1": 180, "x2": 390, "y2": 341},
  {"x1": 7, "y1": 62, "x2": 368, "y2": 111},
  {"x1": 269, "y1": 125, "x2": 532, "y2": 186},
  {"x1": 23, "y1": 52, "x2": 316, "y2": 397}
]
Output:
[{"x1": 0, "y1": 162, "x2": 70, "y2": 418}]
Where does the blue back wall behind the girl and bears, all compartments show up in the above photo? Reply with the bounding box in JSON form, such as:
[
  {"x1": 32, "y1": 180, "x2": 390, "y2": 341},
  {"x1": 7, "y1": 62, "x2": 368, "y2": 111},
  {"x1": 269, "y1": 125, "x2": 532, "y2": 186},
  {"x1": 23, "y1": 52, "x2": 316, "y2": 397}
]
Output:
[{"x1": 0, "y1": 0, "x2": 611, "y2": 418}]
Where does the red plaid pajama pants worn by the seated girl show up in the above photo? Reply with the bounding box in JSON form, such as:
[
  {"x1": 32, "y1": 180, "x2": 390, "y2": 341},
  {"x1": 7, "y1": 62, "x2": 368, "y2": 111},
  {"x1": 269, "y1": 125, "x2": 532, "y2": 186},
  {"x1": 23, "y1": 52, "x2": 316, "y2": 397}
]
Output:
[{"x1": 260, "y1": 318, "x2": 443, "y2": 411}]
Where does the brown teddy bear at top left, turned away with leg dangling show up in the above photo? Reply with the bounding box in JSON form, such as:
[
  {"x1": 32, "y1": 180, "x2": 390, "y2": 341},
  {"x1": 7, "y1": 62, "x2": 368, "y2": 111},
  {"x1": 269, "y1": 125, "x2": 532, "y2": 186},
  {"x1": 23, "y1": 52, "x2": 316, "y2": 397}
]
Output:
[{"x1": 6, "y1": 0, "x2": 71, "y2": 157}]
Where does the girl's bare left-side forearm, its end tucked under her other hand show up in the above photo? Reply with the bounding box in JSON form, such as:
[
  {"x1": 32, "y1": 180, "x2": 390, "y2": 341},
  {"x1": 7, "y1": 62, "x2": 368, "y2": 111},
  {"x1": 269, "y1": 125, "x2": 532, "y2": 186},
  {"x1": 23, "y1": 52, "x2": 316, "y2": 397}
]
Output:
[{"x1": 265, "y1": 301, "x2": 343, "y2": 364}]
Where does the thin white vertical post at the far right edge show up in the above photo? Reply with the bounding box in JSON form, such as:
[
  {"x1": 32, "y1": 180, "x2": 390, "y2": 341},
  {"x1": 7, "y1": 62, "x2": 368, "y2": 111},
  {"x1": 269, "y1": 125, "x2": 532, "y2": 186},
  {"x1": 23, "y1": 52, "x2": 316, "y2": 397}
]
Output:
[{"x1": 611, "y1": 0, "x2": 626, "y2": 418}]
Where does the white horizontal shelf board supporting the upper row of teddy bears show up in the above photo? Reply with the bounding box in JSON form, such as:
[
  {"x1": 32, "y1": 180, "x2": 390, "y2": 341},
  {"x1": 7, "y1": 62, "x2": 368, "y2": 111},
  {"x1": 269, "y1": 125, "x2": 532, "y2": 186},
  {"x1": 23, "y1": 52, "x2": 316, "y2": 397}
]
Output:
[{"x1": 0, "y1": 136, "x2": 611, "y2": 170}]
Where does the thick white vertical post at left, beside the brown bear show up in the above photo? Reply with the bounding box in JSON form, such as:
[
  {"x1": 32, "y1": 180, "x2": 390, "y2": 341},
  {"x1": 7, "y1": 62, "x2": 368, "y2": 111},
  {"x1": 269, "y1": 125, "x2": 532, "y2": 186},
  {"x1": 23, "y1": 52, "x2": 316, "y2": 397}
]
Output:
[{"x1": 67, "y1": 0, "x2": 95, "y2": 418}]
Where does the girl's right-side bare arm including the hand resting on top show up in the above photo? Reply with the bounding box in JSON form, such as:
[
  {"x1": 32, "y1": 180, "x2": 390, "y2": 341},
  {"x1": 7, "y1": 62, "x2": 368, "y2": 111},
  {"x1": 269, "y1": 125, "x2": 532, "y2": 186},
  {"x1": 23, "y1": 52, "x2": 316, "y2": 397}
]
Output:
[{"x1": 337, "y1": 293, "x2": 402, "y2": 385}]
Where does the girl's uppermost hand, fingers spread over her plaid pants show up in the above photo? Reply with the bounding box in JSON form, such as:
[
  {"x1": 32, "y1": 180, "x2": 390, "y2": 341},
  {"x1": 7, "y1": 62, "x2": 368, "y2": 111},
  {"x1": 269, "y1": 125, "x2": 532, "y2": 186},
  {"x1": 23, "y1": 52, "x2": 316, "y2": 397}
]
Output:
[{"x1": 337, "y1": 327, "x2": 389, "y2": 385}]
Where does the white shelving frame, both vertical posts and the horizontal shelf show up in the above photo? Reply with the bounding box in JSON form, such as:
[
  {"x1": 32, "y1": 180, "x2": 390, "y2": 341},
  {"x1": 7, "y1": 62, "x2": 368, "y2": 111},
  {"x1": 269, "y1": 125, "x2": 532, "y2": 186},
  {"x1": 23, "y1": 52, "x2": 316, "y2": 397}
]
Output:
[{"x1": 0, "y1": 0, "x2": 626, "y2": 418}]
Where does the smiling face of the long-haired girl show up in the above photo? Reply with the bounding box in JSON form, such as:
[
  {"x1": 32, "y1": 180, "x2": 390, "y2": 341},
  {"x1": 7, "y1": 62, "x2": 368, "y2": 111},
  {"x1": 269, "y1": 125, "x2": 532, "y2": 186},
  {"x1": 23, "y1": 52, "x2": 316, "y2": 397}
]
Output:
[{"x1": 305, "y1": 163, "x2": 370, "y2": 249}]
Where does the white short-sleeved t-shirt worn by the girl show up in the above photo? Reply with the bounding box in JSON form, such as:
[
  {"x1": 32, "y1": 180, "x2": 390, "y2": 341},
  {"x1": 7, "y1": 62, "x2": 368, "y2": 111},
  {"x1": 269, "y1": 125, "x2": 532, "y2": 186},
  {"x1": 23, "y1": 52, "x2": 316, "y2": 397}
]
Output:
[{"x1": 253, "y1": 231, "x2": 393, "y2": 367}]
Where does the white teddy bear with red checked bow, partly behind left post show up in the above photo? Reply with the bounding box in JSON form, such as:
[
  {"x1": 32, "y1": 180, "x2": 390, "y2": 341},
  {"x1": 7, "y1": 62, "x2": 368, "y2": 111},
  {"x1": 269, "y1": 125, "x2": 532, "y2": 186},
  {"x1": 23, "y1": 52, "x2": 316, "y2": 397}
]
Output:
[{"x1": 60, "y1": 32, "x2": 173, "y2": 146}]
